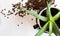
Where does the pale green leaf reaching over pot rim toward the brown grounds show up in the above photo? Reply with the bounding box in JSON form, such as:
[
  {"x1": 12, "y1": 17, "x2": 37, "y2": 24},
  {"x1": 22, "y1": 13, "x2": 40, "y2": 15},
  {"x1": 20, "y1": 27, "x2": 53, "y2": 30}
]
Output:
[{"x1": 20, "y1": 7, "x2": 47, "y2": 21}]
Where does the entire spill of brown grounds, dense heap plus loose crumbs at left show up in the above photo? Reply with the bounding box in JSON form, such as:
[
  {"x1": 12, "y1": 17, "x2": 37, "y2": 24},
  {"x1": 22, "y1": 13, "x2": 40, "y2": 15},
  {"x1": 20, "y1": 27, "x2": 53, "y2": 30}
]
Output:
[{"x1": 1, "y1": 0, "x2": 54, "y2": 17}]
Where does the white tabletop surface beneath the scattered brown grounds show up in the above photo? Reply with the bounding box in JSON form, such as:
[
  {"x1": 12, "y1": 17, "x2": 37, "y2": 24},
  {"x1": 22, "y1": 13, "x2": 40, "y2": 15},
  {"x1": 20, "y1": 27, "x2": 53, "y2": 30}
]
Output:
[{"x1": 0, "y1": 0, "x2": 59, "y2": 36}]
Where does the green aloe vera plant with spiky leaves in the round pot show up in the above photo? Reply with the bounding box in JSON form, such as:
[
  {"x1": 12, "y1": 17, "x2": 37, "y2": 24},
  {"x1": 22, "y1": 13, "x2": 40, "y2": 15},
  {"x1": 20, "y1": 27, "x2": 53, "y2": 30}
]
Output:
[{"x1": 20, "y1": 2, "x2": 60, "y2": 36}]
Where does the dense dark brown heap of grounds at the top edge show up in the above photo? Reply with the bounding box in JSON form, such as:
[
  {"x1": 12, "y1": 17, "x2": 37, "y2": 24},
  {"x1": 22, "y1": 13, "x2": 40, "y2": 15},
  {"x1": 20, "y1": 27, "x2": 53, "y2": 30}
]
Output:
[{"x1": 26, "y1": 0, "x2": 46, "y2": 10}]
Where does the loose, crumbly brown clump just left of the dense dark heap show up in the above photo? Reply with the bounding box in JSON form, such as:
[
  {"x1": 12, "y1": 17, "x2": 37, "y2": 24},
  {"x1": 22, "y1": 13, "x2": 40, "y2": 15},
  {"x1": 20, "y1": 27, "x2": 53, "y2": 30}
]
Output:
[{"x1": 12, "y1": 2, "x2": 26, "y2": 17}]
